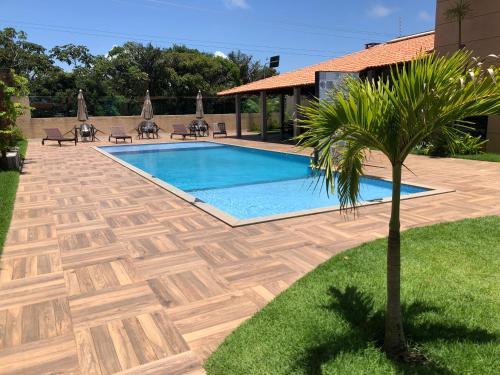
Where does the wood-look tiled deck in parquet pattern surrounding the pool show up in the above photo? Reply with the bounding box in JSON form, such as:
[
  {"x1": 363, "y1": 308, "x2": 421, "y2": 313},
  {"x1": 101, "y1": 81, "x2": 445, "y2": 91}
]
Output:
[{"x1": 0, "y1": 138, "x2": 500, "y2": 375}]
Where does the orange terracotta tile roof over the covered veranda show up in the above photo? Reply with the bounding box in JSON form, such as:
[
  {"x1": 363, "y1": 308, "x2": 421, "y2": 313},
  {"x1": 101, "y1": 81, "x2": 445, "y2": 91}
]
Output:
[{"x1": 218, "y1": 31, "x2": 434, "y2": 96}]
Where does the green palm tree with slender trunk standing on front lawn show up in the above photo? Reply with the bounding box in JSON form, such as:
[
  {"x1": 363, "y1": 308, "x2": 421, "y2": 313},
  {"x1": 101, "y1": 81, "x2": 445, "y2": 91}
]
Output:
[{"x1": 298, "y1": 50, "x2": 500, "y2": 356}]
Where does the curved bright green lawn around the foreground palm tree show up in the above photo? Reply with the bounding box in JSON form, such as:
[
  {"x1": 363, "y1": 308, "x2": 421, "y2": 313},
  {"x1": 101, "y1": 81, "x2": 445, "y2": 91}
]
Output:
[{"x1": 205, "y1": 217, "x2": 500, "y2": 375}]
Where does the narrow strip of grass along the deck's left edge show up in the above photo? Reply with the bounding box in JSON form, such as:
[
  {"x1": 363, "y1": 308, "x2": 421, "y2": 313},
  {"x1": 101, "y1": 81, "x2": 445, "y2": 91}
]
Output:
[{"x1": 0, "y1": 141, "x2": 28, "y2": 255}]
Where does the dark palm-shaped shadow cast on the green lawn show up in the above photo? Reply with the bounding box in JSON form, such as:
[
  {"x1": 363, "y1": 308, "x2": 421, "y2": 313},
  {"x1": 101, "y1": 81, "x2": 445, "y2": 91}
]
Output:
[{"x1": 295, "y1": 286, "x2": 497, "y2": 375}]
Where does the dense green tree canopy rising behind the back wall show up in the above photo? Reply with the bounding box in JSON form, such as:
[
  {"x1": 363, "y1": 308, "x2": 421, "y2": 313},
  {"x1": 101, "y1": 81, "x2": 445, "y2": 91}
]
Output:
[{"x1": 0, "y1": 28, "x2": 276, "y2": 115}]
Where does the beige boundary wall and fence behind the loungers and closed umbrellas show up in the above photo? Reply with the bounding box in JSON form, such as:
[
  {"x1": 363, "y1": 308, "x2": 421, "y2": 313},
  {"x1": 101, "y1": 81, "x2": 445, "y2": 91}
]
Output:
[{"x1": 17, "y1": 96, "x2": 286, "y2": 138}]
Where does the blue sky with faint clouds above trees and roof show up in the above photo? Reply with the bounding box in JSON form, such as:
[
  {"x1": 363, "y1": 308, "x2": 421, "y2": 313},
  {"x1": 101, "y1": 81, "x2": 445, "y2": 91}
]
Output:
[{"x1": 0, "y1": 0, "x2": 436, "y2": 72}]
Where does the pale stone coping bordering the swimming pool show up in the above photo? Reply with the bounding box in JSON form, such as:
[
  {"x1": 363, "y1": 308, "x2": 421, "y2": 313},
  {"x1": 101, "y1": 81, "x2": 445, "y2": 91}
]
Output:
[{"x1": 92, "y1": 140, "x2": 455, "y2": 228}]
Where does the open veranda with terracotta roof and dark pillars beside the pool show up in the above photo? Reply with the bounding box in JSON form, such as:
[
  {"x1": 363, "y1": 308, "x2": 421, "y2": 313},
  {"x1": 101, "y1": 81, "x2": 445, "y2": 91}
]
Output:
[{"x1": 218, "y1": 31, "x2": 434, "y2": 141}]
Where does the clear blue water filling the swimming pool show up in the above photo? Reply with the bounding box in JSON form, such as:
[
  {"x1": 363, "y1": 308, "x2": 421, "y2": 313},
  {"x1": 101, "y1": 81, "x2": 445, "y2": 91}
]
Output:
[{"x1": 101, "y1": 142, "x2": 427, "y2": 220}]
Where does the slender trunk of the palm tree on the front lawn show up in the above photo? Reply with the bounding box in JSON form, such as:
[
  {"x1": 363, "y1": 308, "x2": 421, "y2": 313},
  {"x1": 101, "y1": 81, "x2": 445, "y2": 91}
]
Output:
[{"x1": 384, "y1": 163, "x2": 406, "y2": 356}]
